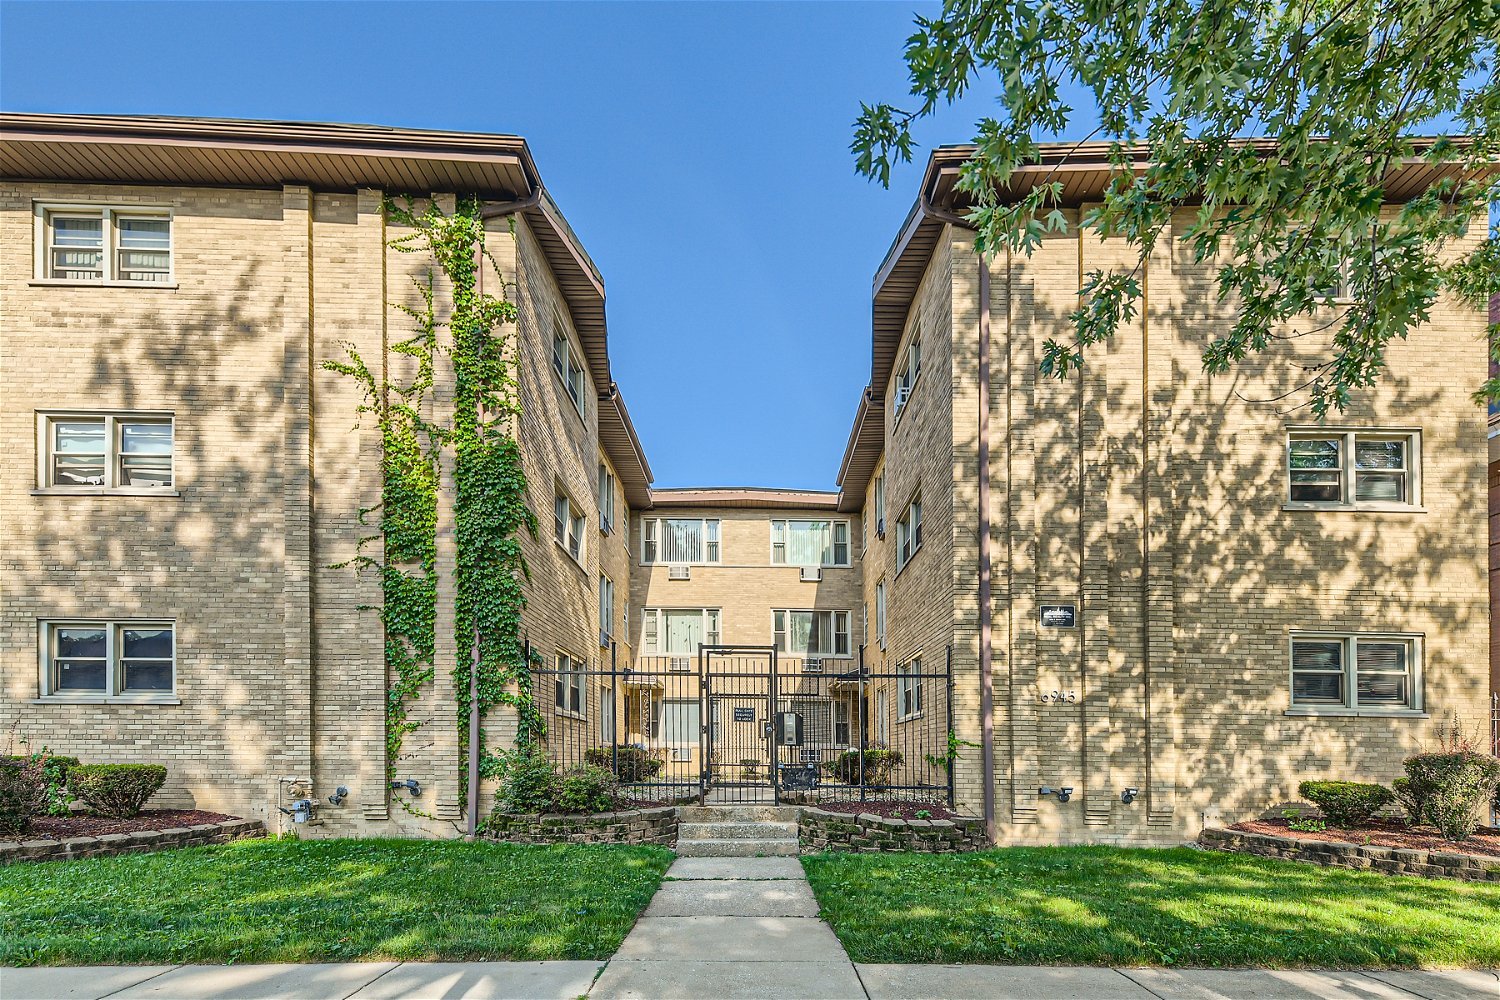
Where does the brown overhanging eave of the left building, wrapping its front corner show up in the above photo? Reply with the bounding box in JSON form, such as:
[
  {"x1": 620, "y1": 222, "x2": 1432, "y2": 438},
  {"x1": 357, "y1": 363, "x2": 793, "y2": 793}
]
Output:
[{"x1": 0, "y1": 112, "x2": 612, "y2": 398}]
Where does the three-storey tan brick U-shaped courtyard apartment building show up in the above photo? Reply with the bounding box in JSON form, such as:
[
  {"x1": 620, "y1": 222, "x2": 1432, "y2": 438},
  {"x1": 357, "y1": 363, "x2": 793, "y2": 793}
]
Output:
[{"x1": 0, "y1": 114, "x2": 1490, "y2": 843}]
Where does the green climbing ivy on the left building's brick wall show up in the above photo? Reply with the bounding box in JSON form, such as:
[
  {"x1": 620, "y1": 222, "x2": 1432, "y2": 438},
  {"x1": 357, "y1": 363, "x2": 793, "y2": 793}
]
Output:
[{"x1": 323, "y1": 198, "x2": 543, "y2": 811}]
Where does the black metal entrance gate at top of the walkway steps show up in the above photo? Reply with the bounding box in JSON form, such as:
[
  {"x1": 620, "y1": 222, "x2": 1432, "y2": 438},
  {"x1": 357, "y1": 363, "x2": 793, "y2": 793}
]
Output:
[{"x1": 698, "y1": 646, "x2": 779, "y2": 804}]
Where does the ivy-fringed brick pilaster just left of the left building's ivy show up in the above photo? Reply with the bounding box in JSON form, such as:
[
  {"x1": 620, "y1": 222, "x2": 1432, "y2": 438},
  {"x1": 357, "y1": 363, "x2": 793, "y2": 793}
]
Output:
[{"x1": 353, "y1": 187, "x2": 390, "y2": 822}]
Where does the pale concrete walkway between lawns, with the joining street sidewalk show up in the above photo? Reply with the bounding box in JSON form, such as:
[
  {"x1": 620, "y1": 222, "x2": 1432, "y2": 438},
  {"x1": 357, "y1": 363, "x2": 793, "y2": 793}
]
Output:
[{"x1": 0, "y1": 858, "x2": 1500, "y2": 1000}]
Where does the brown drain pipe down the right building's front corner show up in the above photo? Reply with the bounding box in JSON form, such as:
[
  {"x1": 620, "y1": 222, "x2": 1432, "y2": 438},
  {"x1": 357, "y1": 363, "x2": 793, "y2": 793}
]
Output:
[{"x1": 918, "y1": 187, "x2": 999, "y2": 844}]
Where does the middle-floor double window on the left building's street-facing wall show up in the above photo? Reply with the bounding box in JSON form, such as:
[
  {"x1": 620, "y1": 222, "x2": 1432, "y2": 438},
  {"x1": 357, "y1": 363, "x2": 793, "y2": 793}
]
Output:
[{"x1": 38, "y1": 414, "x2": 173, "y2": 493}]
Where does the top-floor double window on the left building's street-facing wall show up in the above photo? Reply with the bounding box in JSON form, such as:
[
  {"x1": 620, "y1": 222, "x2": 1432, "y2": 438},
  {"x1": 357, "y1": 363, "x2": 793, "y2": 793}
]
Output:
[{"x1": 38, "y1": 205, "x2": 173, "y2": 285}]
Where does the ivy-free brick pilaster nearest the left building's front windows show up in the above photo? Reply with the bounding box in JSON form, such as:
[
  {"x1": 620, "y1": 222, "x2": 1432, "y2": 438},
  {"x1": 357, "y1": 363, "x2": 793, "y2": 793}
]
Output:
[{"x1": 282, "y1": 184, "x2": 314, "y2": 778}]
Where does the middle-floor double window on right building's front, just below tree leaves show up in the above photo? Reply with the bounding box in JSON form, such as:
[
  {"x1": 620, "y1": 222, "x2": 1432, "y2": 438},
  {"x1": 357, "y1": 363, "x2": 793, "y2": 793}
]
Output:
[{"x1": 1287, "y1": 430, "x2": 1422, "y2": 508}]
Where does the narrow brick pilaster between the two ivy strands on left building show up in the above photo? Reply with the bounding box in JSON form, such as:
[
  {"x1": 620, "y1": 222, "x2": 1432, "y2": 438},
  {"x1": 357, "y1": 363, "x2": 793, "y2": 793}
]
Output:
[{"x1": 428, "y1": 195, "x2": 468, "y2": 820}]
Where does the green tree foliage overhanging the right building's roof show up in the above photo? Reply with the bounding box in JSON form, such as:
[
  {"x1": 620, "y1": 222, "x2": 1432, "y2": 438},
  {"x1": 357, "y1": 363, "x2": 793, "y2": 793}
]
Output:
[{"x1": 852, "y1": 0, "x2": 1500, "y2": 415}]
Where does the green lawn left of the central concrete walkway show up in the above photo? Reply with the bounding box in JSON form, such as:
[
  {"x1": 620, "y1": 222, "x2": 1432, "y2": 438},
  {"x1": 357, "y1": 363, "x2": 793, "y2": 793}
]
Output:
[{"x1": 0, "y1": 840, "x2": 672, "y2": 966}]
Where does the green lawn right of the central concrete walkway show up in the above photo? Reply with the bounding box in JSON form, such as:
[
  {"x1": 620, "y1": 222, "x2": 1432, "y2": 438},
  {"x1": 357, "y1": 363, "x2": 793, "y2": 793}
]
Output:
[{"x1": 803, "y1": 847, "x2": 1500, "y2": 967}]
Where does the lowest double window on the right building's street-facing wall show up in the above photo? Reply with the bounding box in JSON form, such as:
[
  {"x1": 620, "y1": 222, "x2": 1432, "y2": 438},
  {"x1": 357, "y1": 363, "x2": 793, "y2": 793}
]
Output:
[{"x1": 1292, "y1": 634, "x2": 1422, "y2": 711}]
